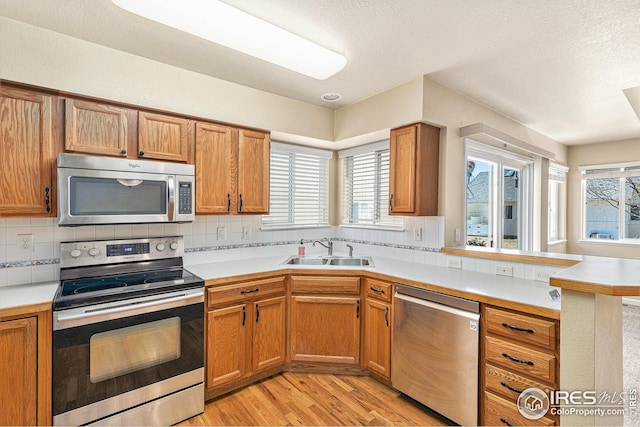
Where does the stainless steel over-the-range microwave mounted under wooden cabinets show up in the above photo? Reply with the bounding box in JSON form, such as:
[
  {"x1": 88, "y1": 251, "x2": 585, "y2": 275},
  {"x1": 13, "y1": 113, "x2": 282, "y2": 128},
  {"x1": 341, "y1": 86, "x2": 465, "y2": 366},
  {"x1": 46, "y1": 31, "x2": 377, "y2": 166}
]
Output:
[{"x1": 58, "y1": 154, "x2": 195, "y2": 226}]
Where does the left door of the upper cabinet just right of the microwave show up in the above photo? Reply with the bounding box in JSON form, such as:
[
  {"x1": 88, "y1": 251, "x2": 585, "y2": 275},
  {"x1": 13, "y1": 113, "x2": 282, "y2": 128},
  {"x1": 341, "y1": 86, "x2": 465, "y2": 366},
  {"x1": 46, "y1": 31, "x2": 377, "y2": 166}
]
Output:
[{"x1": 195, "y1": 123, "x2": 238, "y2": 214}]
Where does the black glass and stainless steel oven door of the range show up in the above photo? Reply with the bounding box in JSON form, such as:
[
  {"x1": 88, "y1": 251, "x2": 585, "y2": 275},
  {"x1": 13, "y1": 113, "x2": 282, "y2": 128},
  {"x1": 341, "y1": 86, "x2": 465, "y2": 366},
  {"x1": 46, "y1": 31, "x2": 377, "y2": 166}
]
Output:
[{"x1": 53, "y1": 288, "x2": 204, "y2": 425}]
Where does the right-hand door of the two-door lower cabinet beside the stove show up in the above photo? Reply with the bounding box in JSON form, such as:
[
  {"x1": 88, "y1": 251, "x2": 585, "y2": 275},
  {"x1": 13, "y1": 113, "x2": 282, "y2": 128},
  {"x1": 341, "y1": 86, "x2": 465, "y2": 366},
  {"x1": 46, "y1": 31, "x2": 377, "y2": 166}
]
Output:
[{"x1": 253, "y1": 296, "x2": 286, "y2": 372}]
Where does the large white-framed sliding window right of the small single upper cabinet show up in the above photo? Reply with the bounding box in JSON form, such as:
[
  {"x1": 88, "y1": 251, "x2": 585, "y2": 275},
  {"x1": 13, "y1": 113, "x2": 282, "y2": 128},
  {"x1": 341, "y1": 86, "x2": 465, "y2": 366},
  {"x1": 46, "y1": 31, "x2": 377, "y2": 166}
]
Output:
[{"x1": 465, "y1": 140, "x2": 533, "y2": 250}]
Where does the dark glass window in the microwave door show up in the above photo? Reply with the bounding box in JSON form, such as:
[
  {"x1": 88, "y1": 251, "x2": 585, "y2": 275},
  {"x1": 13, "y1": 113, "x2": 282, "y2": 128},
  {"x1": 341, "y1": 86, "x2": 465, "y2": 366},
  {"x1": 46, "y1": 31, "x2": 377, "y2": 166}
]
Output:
[{"x1": 69, "y1": 176, "x2": 167, "y2": 215}]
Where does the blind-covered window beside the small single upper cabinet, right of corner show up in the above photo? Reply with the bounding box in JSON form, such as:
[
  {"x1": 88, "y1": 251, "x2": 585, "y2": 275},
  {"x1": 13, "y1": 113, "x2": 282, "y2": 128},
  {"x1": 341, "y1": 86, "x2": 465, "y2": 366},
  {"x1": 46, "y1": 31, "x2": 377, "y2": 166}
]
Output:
[{"x1": 339, "y1": 140, "x2": 403, "y2": 229}]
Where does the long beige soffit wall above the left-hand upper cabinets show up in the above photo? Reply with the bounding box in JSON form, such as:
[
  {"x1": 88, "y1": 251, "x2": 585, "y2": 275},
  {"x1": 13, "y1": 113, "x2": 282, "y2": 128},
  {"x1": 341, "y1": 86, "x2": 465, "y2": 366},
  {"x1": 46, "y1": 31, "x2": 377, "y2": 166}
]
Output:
[{"x1": 0, "y1": 17, "x2": 334, "y2": 141}]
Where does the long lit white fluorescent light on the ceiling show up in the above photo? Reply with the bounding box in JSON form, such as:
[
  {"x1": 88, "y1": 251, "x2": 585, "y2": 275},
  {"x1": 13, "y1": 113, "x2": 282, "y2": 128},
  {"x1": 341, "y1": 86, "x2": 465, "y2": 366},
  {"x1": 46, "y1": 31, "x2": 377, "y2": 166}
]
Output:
[{"x1": 111, "y1": 0, "x2": 347, "y2": 80}]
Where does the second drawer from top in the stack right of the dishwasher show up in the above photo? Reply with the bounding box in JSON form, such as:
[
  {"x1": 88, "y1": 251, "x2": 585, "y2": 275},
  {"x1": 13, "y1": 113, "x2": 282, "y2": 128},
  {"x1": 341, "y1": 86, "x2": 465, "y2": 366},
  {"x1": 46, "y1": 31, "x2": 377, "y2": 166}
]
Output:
[{"x1": 485, "y1": 336, "x2": 556, "y2": 383}]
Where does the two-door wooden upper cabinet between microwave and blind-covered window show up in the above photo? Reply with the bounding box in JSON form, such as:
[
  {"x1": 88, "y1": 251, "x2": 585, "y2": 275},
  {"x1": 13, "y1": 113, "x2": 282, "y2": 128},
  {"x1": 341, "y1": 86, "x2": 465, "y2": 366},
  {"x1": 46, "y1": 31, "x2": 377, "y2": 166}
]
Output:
[{"x1": 195, "y1": 123, "x2": 271, "y2": 214}]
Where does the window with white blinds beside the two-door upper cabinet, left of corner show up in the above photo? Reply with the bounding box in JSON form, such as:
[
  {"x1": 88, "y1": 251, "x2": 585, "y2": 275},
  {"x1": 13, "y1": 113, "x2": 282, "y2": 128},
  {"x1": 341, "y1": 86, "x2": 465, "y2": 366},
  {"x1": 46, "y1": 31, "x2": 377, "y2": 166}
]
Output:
[{"x1": 262, "y1": 142, "x2": 333, "y2": 228}]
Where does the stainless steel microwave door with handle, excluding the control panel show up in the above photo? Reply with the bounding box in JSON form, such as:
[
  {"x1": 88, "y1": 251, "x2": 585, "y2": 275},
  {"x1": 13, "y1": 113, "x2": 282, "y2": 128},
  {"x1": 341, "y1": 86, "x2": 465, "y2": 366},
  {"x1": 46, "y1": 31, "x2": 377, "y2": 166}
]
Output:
[{"x1": 58, "y1": 168, "x2": 176, "y2": 225}]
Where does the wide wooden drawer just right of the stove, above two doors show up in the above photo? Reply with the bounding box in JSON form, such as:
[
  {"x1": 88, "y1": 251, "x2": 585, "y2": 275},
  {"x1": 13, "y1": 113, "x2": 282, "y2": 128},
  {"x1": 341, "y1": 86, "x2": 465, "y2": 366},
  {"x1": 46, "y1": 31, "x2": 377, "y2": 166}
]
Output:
[{"x1": 207, "y1": 276, "x2": 284, "y2": 307}]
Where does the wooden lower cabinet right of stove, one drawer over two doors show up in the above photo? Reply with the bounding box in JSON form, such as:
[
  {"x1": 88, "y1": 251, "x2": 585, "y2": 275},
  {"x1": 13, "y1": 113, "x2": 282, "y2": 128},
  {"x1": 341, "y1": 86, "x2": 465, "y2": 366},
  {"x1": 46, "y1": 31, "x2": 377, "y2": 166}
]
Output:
[{"x1": 206, "y1": 276, "x2": 286, "y2": 395}]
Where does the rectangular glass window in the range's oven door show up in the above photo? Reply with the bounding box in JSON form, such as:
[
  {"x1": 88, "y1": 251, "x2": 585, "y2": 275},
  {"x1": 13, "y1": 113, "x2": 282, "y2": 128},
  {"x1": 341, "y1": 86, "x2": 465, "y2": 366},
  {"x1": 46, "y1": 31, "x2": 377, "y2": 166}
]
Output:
[{"x1": 89, "y1": 317, "x2": 180, "y2": 384}]
